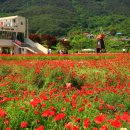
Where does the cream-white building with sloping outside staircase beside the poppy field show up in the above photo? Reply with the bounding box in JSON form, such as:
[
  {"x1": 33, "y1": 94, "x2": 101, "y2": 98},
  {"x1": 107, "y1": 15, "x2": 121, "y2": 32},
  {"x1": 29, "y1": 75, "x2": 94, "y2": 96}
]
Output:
[{"x1": 0, "y1": 16, "x2": 48, "y2": 54}]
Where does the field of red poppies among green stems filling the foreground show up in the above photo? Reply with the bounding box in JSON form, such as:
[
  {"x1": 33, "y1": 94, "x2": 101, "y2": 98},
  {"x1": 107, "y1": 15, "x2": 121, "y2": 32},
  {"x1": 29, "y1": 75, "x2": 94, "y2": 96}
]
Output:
[{"x1": 0, "y1": 53, "x2": 130, "y2": 130}]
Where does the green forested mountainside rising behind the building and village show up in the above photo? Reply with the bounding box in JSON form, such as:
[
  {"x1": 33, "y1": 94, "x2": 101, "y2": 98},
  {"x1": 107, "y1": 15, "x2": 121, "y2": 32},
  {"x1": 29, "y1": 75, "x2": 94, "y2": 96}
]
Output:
[{"x1": 0, "y1": 0, "x2": 130, "y2": 36}]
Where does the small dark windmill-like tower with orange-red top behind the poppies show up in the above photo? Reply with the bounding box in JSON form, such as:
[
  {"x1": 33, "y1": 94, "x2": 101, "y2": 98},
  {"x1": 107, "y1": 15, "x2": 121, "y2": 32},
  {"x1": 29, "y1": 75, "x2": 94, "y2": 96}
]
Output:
[{"x1": 96, "y1": 34, "x2": 105, "y2": 53}]
